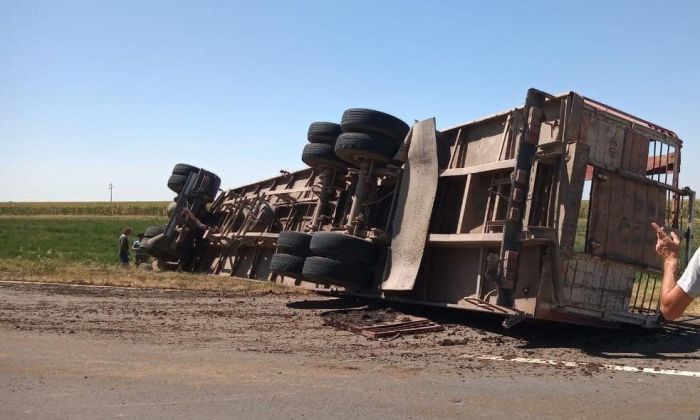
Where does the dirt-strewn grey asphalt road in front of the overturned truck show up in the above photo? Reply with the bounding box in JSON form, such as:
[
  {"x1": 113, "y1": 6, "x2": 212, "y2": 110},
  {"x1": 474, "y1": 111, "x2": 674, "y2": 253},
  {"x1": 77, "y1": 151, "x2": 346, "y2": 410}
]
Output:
[{"x1": 0, "y1": 284, "x2": 700, "y2": 419}]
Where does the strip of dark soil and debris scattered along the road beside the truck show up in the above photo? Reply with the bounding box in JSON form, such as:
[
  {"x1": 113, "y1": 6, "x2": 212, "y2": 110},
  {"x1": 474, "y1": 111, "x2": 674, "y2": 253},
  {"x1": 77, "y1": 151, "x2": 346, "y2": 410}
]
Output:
[{"x1": 0, "y1": 282, "x2": 700, "y2": 375}]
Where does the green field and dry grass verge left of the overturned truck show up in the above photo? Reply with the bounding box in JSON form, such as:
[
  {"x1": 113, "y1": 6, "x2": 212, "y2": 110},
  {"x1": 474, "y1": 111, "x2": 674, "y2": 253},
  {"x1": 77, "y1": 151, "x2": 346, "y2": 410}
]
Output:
[{"x1": 0, "y1": 215, "x2": 302, "y2": 293}]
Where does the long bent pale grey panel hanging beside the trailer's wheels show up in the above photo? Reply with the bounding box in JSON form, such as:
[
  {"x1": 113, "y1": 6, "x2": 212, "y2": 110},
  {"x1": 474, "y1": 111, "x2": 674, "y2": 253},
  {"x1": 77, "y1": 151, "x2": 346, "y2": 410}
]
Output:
[{"x1": 382, "y1": 118, "x2": 439, "y2": 290}]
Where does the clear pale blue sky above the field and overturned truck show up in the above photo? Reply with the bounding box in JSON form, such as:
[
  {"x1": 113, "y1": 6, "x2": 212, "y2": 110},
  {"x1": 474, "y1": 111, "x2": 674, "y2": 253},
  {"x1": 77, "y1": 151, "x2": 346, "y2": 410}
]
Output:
[{"x1": 0, "y1": 0, "x2": 700, "y2": 201}]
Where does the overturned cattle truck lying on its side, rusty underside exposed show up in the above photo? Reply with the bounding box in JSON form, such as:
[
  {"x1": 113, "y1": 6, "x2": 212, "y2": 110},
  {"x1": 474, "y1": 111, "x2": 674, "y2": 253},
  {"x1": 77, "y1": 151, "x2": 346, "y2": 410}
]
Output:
[{"x1": 145, "y1": 89, "x2": 694, "y2": 327}]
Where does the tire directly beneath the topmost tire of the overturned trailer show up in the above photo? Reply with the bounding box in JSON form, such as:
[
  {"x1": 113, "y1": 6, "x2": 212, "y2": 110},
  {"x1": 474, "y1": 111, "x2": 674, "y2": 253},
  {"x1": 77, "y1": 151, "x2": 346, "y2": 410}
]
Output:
[{"x1": 335, "y1": 133, "x2": 397, "y2": 166}]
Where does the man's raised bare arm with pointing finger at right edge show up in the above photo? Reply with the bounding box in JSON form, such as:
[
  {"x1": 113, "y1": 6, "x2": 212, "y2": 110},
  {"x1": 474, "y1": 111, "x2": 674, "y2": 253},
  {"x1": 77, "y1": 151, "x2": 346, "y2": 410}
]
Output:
[{"x1": 651, "y1": 222, "x2": 700, "y2": 320}]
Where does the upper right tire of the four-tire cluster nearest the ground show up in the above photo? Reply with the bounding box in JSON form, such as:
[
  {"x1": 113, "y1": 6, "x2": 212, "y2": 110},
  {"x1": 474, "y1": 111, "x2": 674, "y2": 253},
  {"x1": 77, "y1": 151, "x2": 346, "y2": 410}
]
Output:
[{"x1": 309, "y1": 231, "x2": 378, "y2": 266}]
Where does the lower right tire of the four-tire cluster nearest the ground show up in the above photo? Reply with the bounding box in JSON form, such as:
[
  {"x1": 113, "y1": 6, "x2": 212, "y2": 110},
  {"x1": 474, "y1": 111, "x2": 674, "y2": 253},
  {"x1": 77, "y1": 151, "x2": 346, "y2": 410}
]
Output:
[{"x1": 302, "y1": 257, "x2": 373, "y2": 289}]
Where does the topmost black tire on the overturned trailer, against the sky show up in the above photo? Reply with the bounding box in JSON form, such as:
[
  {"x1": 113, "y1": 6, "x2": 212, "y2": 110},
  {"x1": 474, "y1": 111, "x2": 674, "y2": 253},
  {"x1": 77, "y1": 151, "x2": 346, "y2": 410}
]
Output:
[{"x1": 340, "y1": 108, "x2": 410, "y2": 146}]
